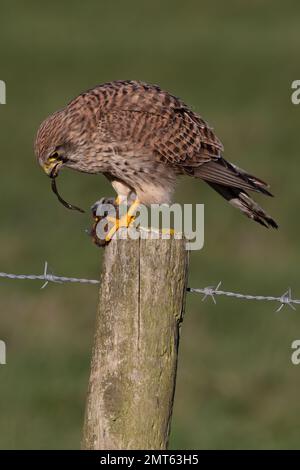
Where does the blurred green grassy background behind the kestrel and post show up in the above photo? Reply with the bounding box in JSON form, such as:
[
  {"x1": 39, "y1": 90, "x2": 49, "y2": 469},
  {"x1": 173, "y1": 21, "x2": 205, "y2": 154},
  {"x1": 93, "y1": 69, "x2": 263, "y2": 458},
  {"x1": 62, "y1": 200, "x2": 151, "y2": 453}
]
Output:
[{"x1": 0, "y1": 0, "x2": 300, "y2": 449}]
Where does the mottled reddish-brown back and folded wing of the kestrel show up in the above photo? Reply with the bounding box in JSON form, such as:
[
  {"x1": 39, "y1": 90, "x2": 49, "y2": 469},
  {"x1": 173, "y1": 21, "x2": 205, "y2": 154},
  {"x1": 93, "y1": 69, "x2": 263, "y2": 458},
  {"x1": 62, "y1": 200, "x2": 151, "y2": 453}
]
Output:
[{"x1": 71, "y1": 81, "x2": 223, "y2": 166}]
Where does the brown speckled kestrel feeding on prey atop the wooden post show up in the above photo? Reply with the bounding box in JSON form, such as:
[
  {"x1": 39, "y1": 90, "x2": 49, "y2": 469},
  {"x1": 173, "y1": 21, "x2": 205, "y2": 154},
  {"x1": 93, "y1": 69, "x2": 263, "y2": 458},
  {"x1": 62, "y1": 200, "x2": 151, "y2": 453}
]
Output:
[{"x1": 35, "y1": 80, "x2": 278, "y2": 241}]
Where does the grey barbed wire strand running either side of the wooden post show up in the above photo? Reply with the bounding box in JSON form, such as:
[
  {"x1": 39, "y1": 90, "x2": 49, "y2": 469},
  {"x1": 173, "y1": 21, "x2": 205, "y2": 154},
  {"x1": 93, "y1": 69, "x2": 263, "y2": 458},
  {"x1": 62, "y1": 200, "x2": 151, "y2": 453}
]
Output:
[{"x1": 0, "y1": 261, "x2": 300, "y2": 312}]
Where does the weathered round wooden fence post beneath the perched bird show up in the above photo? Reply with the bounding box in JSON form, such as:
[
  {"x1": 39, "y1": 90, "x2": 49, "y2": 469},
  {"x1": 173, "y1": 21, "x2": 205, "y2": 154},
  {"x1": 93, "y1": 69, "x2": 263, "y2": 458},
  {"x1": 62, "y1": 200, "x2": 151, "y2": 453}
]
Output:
[{"x1": 82, "y1": 238, "x2": 188, "y2": 450}]
